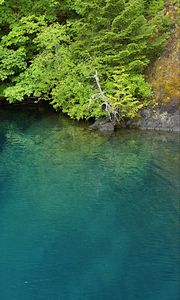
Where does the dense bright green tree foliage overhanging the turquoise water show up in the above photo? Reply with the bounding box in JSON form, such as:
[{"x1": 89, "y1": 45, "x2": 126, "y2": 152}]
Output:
[{"x1": 0, "y1": 0, "x2": 172, "y2": 119}]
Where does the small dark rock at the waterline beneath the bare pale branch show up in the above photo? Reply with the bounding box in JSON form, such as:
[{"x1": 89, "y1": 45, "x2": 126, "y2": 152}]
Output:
[{"x1": 90, "y1": 118, "x2": 114, "y2": 133}]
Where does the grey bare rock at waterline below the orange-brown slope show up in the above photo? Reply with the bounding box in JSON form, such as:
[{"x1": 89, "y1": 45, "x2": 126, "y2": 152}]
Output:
[{"x1": 136, "y1": 106, "x2": 180, "y2": 132}]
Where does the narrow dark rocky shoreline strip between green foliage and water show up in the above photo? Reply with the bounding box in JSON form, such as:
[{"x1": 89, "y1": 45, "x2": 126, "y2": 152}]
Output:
[{"x1": 0, "y1": 98, "x2": 180, "y2": 133}]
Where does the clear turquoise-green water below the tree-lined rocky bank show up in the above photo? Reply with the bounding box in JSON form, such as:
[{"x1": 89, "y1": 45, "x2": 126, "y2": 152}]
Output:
[{"x1": 0, "y1": 109, "x2": 179, "y2": 300}]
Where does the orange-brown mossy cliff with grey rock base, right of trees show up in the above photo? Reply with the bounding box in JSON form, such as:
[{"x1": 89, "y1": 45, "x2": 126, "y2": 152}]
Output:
[{"x1": 139, "y1": 0, "x2": 180, "y2": 131}]
